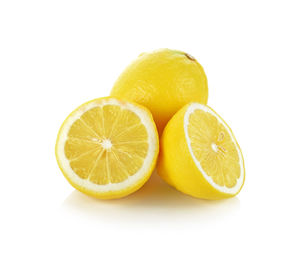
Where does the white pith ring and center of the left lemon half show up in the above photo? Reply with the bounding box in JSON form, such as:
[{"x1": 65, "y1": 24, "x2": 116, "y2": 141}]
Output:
[{"x1": 57, "y1": 98, "x2": 158, "y2": 193}]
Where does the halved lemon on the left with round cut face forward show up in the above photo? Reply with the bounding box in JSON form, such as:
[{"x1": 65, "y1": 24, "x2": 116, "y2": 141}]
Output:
[{"x1": 56, "y1": 97, "x2": 159, "y2": 199}]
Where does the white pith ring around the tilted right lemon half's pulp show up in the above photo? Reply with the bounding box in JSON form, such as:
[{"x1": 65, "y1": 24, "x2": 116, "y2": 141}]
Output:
[{"x1": 184, "y1": 103, "x2": 245, "y2": 194}]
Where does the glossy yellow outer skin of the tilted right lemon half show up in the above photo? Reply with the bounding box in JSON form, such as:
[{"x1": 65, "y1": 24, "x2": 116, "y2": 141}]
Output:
[{"x1": 157, "y1": 104, "x2": 245, "y2": 200}]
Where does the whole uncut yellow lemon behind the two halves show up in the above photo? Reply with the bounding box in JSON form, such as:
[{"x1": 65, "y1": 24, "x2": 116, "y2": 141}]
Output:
[{"x1": 111, "y1": 49, "x2": 208, "y2": 134}]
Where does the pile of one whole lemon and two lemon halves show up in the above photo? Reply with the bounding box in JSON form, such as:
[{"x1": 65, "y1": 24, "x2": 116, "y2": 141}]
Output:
[{"x1": 56, "y1": 49, "x2": 245, "y2": 199}]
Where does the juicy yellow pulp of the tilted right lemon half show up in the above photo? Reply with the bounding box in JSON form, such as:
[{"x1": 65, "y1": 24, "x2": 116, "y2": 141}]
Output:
[{"x1": 188, "y1": 109, "x2": 241, "y2": 188}]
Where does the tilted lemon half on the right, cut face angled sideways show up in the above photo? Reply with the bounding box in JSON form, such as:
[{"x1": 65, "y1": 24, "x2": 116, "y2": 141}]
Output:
[{"x1": 158, "y1": 103, "x2": 245, "y2": 199}]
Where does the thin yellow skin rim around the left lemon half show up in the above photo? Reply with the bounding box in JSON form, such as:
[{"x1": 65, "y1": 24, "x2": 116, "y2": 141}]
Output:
[{"x1": 55, "y1": 97, "x2": 159, "y2": 199}]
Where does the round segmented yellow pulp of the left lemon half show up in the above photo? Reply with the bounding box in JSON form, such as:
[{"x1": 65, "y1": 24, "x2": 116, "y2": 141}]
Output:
[{"x1": 65, "y1": 105, "x2": 148, "y2": 185}]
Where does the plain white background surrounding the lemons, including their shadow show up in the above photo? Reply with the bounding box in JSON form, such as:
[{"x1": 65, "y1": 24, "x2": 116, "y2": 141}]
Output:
[{"x1": 0, "y1": 0, "x2": 300, "y2": 255}]
